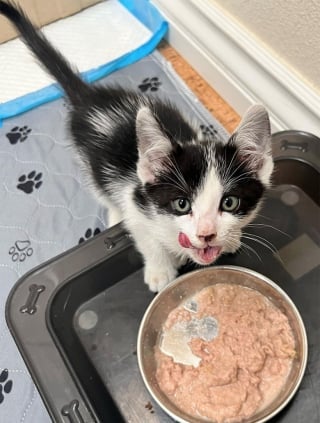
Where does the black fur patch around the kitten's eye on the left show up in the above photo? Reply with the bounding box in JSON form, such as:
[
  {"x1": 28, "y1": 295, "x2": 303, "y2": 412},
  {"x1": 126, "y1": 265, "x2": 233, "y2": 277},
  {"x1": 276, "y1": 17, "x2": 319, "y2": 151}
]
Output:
[{"x1": 135, "y1": 143, "x2": 207, "y2": 215}]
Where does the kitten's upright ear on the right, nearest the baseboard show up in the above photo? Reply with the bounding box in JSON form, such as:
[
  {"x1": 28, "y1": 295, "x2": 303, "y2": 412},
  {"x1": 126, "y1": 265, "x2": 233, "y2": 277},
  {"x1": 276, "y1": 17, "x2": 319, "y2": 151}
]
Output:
[{"x1": 232, "y1": 105, "x2": 273, "y2": 185}]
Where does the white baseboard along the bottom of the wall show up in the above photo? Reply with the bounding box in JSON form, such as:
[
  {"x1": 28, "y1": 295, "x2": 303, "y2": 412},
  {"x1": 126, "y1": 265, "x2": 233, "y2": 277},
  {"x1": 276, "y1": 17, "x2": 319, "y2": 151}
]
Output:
[{"x1": 152, "y1": 0, "x2": 320, "y2": 136}]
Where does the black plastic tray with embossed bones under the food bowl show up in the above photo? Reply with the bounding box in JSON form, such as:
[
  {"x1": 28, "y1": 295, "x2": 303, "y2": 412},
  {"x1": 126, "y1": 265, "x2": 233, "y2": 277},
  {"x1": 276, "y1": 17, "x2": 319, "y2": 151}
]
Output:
[{"x1": 7, "y1": 132, "x2": 320, "y2": 423}]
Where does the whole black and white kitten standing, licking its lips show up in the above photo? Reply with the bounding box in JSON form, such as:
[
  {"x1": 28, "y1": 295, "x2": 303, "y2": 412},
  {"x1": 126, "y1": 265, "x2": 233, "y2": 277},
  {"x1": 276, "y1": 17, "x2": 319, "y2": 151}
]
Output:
[{"x1": 0, "y1": 1, "x2": 273, "y2": 292}]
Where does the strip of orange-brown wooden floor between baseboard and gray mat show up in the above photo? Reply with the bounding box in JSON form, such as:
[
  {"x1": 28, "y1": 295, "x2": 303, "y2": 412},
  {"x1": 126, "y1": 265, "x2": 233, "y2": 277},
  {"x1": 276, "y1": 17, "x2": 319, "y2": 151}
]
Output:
[{"x1": 158, "y1": 41, "x2": 240, "y2": 132}]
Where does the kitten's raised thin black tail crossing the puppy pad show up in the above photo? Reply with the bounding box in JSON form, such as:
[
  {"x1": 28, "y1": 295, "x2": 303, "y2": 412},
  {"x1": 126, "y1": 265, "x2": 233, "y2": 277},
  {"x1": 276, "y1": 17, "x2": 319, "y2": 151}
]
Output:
[{"x1": 0, "y1": 0, "x2": 91, "y2": 105}]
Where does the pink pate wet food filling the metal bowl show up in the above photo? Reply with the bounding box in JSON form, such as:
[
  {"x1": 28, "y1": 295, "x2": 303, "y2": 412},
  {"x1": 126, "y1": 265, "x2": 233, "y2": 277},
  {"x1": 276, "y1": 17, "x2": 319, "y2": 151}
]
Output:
[{"x1": 156, "y1": 284, "x2": 295, "y2": 423}]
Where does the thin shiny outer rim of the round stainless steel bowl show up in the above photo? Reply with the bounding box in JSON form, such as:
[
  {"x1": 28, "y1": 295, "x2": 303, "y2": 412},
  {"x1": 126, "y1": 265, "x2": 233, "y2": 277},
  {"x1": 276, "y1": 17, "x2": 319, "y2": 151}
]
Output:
[{"x1": 137, "y1": 265, "x2": 308, "y2": 423}]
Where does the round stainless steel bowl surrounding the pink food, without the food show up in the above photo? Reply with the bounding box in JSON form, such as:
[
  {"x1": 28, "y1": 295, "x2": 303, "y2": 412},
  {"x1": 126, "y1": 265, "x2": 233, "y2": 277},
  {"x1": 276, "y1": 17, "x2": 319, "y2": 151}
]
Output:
[{"x1": 137, "y1": 266, "x2": 308, "y2": 423}]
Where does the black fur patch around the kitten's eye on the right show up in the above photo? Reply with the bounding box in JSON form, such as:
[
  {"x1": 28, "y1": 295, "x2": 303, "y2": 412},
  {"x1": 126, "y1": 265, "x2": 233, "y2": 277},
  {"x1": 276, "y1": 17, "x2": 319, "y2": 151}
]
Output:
[{"x1": 216, "y1": 142, "x2": 265, "y2": 216}]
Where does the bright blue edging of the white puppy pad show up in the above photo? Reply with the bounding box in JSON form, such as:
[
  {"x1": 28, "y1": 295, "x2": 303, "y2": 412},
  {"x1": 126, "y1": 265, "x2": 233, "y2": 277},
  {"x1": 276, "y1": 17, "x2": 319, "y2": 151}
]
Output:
[{"x1": 0, "y1": 0, "x2": 168, "y2": 127}]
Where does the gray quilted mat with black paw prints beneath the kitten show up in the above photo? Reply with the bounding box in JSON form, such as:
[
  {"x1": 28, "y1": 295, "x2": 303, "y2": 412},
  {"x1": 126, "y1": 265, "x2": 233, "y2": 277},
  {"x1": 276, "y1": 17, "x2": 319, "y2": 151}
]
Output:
[{"x1": 0, "y1": 52, "x2": 227, "y2": 423}]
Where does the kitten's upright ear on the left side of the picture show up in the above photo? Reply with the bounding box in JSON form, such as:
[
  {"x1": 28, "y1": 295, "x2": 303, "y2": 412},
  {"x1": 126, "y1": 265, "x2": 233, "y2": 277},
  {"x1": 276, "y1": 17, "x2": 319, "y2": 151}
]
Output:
[{"x1": 136, "y1": 107, "x2": 172, "y2": 184}]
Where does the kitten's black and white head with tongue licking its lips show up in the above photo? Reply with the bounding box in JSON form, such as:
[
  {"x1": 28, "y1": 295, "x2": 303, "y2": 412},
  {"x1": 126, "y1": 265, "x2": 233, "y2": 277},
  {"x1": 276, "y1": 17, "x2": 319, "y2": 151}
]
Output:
[{"x1": 136, "y1": 105, "x2": 273, "y2": 264}]
